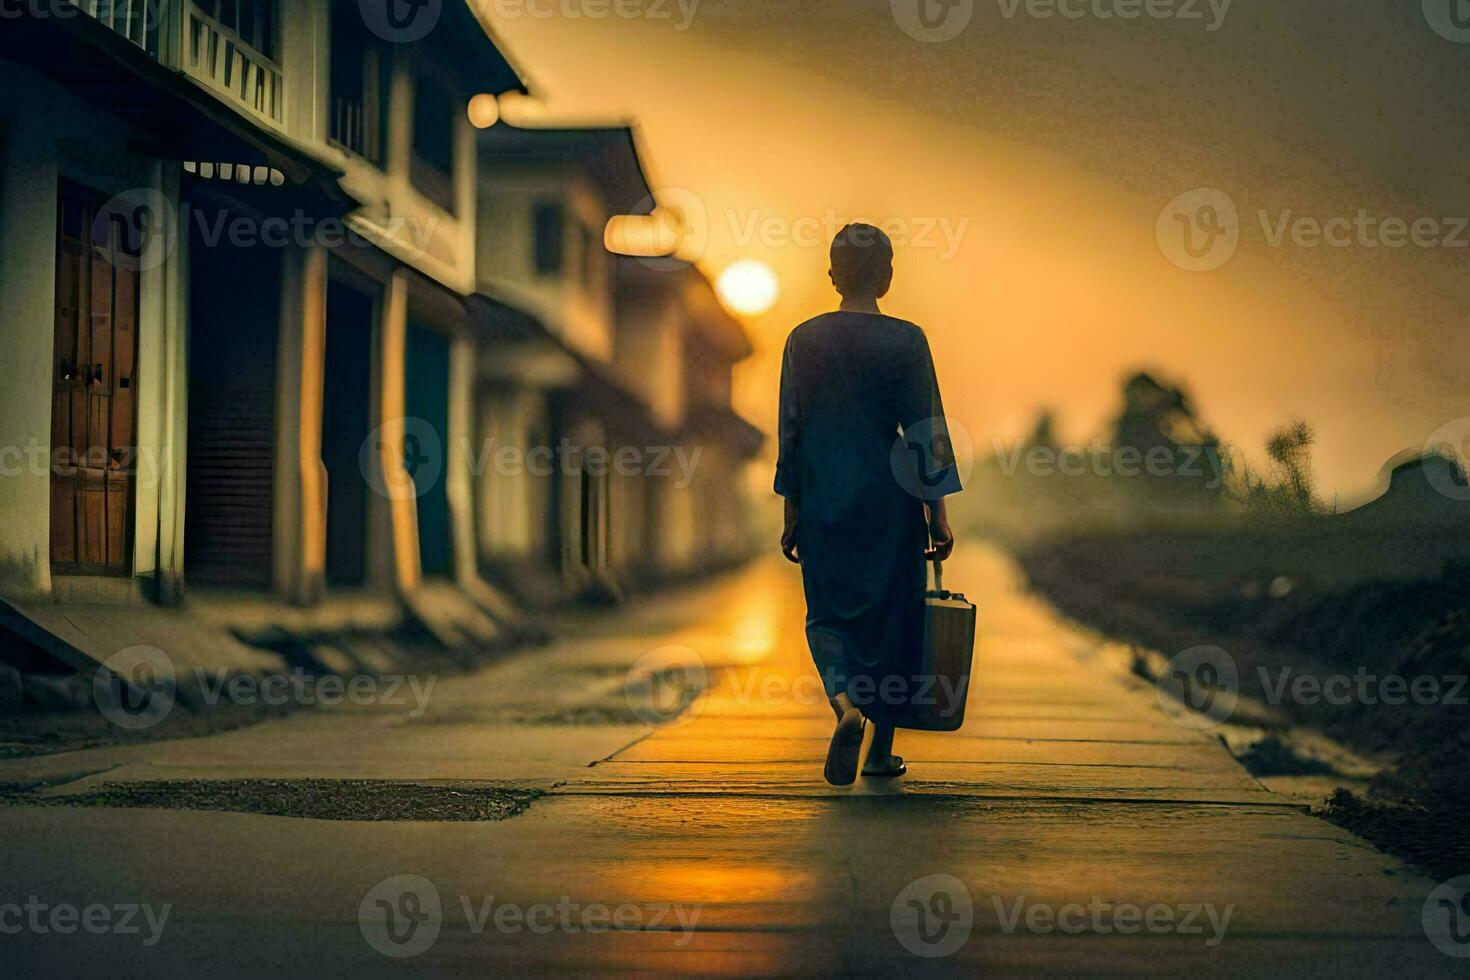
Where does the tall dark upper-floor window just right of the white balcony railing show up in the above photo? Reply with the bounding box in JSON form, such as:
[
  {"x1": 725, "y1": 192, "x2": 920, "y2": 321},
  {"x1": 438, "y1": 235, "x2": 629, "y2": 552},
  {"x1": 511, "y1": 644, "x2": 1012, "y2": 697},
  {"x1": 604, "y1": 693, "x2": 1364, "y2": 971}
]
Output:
[{"x1": 331, "y1": 6, "x2": 392, "y2": 166}]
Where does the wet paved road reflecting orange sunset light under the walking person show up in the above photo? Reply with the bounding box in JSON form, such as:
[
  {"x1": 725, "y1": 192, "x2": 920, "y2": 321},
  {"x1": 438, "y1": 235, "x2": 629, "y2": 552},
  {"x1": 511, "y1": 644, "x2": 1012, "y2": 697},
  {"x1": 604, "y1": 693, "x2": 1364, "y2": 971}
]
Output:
[{"x1": 0, "y1": 547, "x2": 1461, "y2": 977}]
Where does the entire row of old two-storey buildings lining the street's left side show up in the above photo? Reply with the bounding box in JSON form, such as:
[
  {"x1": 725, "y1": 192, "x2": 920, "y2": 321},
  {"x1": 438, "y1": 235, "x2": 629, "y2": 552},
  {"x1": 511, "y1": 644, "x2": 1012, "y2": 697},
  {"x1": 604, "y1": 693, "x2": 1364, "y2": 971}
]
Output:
[{"x1": 0, "y1": 0, "x2": 760, "y2": 675}]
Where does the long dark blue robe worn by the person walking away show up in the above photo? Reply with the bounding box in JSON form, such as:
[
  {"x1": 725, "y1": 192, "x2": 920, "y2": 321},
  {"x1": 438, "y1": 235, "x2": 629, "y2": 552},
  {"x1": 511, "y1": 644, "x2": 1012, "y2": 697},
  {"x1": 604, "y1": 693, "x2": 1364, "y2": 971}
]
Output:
[{"x1": 776, "y1": 313, "x2": 960, "y2": 724}]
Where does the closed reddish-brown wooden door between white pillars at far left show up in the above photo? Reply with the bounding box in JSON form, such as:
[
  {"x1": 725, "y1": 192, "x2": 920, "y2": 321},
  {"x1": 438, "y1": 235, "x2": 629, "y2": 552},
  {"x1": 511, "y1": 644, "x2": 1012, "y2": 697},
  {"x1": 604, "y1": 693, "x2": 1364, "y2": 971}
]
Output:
[{"x1": 51, "y1": 185, "x2": 138, "y2": 574}]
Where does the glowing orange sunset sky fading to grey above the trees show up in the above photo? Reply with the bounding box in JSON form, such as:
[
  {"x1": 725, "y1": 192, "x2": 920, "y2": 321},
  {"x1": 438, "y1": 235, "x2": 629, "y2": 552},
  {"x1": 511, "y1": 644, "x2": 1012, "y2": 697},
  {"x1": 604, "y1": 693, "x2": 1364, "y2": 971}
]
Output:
[{"x1": 488, "y1": 0, "x2": 1470, "y2": 502}]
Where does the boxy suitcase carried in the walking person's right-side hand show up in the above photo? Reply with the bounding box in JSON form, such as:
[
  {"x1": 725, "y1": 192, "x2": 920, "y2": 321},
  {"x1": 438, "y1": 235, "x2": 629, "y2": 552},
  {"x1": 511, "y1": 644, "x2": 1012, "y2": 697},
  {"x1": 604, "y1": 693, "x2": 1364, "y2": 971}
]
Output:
[{"x1": 901, "y1": 561, "x2": 975, "y2": 732}]
